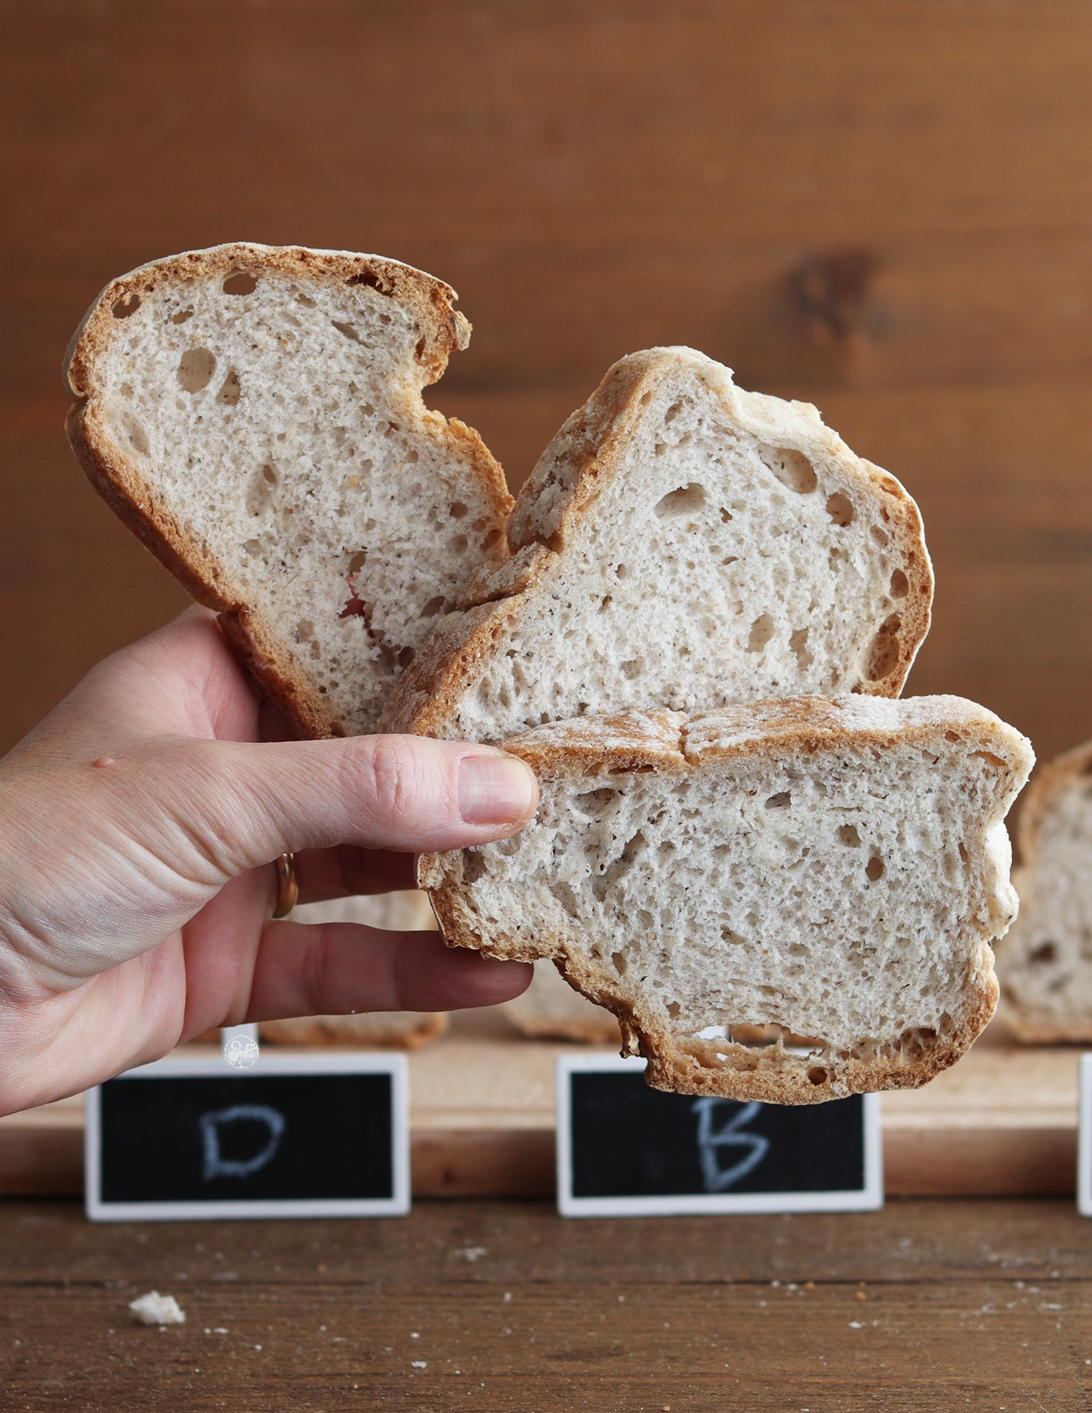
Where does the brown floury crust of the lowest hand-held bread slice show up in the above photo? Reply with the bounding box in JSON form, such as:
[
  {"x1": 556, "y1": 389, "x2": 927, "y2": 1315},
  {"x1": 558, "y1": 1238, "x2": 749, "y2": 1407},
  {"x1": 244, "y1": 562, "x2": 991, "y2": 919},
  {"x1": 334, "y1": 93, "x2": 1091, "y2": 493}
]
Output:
[{"x1": 418, "y1": 697, "x2": 1034, "y2": 1104}]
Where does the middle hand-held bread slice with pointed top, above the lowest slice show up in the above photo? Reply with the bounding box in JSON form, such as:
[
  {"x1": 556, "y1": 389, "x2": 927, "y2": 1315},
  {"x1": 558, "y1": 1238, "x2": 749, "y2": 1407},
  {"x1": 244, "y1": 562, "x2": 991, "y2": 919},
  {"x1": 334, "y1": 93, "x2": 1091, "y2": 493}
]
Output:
[{"x1": 381, "y1": 348, "x2": 932, "y2": 742}]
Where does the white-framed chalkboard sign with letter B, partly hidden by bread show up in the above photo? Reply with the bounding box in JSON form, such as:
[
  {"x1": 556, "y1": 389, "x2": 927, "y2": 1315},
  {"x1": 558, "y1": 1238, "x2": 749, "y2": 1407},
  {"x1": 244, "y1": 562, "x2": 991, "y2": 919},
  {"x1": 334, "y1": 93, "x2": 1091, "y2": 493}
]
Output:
[{"x1": 557, "y1": 1056, "x2": 883, "y2": 1217}]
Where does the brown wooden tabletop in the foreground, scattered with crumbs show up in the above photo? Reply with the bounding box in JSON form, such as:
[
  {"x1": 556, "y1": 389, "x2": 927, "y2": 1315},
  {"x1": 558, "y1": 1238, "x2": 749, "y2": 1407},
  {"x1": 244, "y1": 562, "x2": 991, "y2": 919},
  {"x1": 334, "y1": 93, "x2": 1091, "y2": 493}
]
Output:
[{"x1": 0, "y1": 1200, "x2": 1092, "y2": 1413}]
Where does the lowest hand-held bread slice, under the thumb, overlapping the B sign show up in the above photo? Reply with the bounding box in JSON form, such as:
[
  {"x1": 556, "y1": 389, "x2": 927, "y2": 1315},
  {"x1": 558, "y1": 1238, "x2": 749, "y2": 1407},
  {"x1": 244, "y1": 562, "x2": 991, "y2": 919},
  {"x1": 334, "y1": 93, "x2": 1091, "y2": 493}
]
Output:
[{"x1": 418, "y1": 697, "x2": 1034, "y2": 1104}]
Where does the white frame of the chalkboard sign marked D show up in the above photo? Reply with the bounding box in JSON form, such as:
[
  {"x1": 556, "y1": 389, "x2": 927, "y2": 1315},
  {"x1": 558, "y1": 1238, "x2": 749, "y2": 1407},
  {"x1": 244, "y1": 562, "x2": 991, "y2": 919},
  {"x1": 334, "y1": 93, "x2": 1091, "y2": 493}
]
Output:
[{"x1": 83, "y1": 1051, "x2": 411, "y2": 1222}]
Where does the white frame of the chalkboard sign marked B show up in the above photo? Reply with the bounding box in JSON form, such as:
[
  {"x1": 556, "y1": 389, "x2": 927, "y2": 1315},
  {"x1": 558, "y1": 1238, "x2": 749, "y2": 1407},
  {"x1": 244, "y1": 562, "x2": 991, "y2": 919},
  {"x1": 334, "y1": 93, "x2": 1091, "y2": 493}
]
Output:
[{"x1": 555, "y1": 1054, "x2": 887, "y2": 1217}]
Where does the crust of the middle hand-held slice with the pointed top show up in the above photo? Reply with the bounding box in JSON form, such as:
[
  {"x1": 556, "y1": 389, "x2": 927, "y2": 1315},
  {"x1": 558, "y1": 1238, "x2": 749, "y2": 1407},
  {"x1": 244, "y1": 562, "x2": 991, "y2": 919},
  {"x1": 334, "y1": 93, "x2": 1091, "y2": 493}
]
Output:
[{"x1": 380, "y1": 349, "x2": 932, "y2": 736}]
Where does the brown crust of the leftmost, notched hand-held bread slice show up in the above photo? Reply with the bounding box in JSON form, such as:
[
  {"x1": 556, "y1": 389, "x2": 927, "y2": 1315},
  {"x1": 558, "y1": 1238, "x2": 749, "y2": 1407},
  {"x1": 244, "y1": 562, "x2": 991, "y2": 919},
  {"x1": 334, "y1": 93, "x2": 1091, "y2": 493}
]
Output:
[{"x1": 64, "y1": 242, "x2": 513, "y2": 738}]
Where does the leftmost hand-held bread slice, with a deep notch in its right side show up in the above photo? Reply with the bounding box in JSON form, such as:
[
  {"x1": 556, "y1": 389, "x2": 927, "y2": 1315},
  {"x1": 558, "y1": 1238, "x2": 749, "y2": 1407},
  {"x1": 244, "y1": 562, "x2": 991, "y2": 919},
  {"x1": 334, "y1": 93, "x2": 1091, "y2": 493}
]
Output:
[{"x1": 65, "y1": 244, "x2": 511, "y2": 736}]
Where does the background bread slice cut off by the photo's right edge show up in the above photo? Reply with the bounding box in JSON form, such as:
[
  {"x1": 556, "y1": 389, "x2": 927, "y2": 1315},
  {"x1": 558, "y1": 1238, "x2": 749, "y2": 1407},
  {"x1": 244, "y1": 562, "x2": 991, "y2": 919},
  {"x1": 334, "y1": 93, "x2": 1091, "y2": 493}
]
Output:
[{"x1": 997, "y1": 740, "x2": 1092, "y2": 1043}]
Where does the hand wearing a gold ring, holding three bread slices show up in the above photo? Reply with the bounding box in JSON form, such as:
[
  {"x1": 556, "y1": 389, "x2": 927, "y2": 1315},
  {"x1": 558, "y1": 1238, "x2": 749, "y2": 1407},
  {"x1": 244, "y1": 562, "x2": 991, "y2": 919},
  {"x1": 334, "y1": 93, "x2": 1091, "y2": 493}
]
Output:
[{"x1": 0, "y1": 608, "x2": 538, "y2": 1113}]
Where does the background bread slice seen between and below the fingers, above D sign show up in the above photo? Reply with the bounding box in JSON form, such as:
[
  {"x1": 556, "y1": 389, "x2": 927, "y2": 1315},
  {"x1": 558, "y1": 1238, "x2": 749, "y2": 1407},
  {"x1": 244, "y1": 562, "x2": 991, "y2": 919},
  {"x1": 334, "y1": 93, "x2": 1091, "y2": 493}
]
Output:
[{"x1": 259, "y1": 889, "x2": 448, "y2": 1050}]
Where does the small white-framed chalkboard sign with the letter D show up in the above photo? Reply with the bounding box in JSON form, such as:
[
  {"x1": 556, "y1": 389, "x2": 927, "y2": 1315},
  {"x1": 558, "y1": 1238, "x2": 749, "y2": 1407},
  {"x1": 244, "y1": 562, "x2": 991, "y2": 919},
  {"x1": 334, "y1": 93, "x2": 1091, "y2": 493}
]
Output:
[{"x1": 85, "y1": 1053, "x2": 410, "y2": 1221}]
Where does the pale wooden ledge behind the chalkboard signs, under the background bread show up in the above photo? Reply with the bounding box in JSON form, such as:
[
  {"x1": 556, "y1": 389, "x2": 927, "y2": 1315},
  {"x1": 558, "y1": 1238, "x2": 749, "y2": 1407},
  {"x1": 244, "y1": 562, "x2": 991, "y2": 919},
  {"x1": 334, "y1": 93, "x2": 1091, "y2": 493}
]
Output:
[{"x1": 0, "y1": 1012, "x2": 1079, "y2": 1197}]
